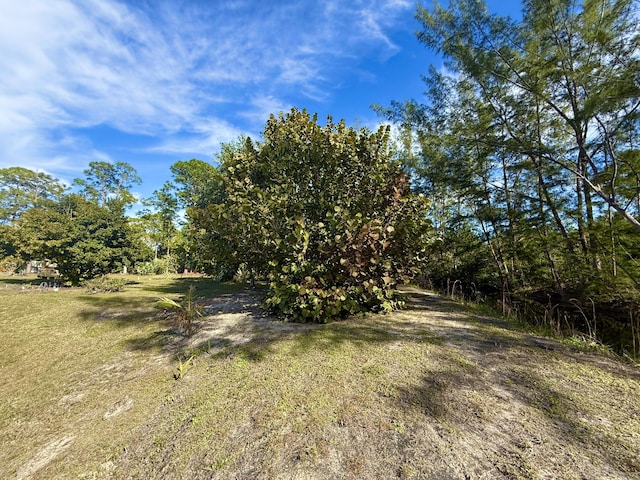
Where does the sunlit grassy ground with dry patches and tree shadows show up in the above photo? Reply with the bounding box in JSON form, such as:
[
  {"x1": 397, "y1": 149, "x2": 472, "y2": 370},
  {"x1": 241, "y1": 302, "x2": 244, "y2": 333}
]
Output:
[{"x1": 0, "y1": 277, "x2": 640, "y2": 479}]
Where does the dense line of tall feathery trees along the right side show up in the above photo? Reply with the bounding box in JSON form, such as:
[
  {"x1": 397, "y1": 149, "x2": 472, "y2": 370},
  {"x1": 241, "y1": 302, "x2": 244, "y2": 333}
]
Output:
[{"x1": 379, "y1": 0, "x2": 640, "y2": 352}]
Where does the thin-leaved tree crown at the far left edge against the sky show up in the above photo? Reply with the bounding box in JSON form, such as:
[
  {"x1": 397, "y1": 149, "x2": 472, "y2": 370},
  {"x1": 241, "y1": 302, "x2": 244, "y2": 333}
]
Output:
[{"x1": 0, "y1": 167, "x2": 65, "y2": 224}]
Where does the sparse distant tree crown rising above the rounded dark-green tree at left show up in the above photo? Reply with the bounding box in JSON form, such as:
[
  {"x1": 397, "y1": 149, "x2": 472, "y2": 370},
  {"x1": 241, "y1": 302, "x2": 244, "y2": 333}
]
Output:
[{"x1": 74, "y1": 161, "x2": 141, "y2": 207}]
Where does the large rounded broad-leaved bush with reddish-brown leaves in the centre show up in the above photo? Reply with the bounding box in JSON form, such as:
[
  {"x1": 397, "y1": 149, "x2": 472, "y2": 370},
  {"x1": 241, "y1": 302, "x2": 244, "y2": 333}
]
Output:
[{"x1": 202, "y1": 109, "x2": 428, "y2": 322}]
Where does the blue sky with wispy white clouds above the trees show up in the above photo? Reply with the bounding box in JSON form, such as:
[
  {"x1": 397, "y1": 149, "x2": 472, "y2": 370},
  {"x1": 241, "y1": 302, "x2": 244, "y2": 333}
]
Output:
[{"x1": 0, "y1": 0, "x2": 520, "y2": 204}]
